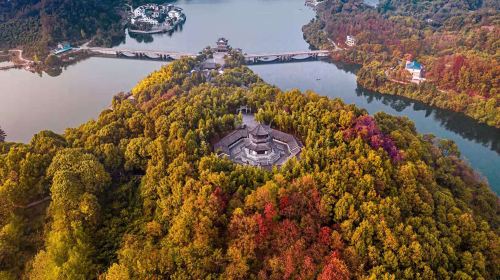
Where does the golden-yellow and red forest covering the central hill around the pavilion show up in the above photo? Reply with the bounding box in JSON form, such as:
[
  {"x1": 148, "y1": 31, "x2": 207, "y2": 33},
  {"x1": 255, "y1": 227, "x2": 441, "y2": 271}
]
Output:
[{"x1": 0, "y1": 59, "x2": 500, "y2": 280}]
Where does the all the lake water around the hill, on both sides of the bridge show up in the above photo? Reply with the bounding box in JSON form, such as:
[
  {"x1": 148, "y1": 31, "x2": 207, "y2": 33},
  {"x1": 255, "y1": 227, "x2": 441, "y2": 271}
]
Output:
[{"x1": 0, "y1": 0, "x2": 500, "y2": 193}]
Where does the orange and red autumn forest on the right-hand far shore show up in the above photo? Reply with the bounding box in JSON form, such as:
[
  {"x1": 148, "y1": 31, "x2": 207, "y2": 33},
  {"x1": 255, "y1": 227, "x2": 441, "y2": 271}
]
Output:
[{"x1": 303, "y1": 0, "x2": 500, "y2": 127}]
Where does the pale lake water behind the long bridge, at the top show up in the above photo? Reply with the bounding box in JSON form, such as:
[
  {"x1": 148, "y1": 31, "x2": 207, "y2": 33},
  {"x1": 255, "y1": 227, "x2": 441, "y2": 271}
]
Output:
[{"x1": 117, "y1": 0, "x2": 314, "y2": 53}]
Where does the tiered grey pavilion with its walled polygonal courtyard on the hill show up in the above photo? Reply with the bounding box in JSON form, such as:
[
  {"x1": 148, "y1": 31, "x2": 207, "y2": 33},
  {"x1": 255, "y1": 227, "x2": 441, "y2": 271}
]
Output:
[{"x1": 214, "y1": 121, "x2": 301, "y2": 168}]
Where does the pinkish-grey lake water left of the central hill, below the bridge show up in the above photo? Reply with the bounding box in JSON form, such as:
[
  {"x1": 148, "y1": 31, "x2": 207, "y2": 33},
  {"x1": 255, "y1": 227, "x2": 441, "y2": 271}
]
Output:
[{"x1": 0, "y1": 58, "x2": 161, "y2": 142}]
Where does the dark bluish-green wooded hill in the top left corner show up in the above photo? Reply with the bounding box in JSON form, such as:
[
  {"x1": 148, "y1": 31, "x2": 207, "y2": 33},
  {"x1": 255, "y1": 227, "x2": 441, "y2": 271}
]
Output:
[{"x1": 0, "y1": 0, "x2": 165, "y2": 60}]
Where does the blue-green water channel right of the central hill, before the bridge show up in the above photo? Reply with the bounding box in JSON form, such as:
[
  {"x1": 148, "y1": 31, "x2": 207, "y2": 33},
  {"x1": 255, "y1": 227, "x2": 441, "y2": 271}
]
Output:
[{"x1": 251, "y1": 61, "x2": 500, "y2": 193}]
